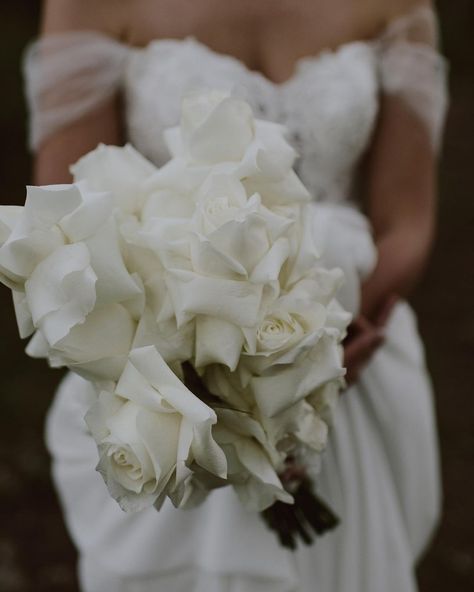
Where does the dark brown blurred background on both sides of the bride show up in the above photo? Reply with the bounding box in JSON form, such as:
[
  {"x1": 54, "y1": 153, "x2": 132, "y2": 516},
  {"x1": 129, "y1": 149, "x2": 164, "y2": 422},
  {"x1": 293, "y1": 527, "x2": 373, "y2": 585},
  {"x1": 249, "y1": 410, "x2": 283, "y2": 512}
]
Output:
[{"x1": 0, "y1": 0, "x2": 474, "y2": 592}]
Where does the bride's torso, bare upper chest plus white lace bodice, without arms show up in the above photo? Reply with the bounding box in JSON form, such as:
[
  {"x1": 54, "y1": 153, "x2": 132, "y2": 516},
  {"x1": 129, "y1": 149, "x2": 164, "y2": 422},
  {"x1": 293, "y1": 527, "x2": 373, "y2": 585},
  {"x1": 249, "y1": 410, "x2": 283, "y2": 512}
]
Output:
[{"x1": 124, "y1": 0, "x2": 386, "y2": 201}]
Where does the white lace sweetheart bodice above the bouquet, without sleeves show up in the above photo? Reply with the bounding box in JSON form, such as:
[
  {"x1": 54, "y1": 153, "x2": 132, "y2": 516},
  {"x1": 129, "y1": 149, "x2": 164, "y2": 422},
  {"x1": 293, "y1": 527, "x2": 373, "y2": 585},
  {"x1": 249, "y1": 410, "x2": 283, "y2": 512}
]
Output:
[{"x1": 125, "y1": 38, "x2": 378, "y2": 202}]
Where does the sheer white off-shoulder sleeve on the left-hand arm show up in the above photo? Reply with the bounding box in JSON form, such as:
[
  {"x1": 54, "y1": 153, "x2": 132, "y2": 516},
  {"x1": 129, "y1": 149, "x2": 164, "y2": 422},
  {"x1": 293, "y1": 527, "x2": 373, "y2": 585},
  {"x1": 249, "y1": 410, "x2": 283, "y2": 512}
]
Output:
[{"x1": 23, "y1": 31, "x2": 129, "y2": 150}]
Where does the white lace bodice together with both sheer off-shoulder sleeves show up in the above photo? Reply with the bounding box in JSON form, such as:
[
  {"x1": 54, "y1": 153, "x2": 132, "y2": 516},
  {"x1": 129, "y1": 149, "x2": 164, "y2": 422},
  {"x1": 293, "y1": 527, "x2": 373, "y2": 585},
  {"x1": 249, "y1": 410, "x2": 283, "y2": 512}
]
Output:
[{"x1": 26, "y1": 8, "x2": 446, "y2": 206}]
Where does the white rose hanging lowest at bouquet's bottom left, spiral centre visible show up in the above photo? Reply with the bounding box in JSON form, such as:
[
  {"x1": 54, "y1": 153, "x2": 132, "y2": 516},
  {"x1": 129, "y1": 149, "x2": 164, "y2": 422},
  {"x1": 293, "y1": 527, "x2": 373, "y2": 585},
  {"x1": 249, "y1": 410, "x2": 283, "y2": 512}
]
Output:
[{"x1": 86, "y1": 347, "x2": 226, "y2": 511}]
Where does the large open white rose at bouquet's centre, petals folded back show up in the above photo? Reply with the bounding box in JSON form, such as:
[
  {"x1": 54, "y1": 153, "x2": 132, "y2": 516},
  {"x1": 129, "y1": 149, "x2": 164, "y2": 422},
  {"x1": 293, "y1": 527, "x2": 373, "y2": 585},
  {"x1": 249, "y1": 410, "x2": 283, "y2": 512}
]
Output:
[{"x1": 141, "y1": 174, "x2": 294, "y2": 369}]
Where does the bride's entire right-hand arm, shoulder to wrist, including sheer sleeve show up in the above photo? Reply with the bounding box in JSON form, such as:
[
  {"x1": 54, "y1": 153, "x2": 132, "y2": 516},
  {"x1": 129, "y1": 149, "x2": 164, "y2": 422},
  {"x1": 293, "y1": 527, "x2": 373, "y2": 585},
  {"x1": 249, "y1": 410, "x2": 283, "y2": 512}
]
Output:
[{"x1": 362, "y1": 0, "x2": 446, "y2": 318}]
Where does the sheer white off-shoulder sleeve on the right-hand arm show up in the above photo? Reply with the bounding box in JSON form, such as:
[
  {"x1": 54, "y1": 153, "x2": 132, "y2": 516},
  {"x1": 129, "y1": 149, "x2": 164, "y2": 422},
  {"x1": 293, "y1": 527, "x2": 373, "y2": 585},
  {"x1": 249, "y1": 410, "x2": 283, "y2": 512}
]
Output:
[{"x1": 379, "y1": 5, "x2": 448, "y2": 150}]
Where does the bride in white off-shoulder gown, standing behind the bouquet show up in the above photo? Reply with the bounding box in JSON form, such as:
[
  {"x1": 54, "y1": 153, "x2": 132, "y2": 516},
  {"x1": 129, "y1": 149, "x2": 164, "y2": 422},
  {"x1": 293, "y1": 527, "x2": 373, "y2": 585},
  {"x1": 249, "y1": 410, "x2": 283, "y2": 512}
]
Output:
[{"x1": 25, "y1": 0, "x2": 446, "y2": 592}]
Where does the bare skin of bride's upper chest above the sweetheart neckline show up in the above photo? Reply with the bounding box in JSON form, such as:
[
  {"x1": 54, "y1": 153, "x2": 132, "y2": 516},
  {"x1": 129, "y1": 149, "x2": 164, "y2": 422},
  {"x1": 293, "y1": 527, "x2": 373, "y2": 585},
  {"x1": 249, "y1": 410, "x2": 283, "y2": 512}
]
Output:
[{"x1": 125, "y1": 0, "x2": 381, "y2": 83}]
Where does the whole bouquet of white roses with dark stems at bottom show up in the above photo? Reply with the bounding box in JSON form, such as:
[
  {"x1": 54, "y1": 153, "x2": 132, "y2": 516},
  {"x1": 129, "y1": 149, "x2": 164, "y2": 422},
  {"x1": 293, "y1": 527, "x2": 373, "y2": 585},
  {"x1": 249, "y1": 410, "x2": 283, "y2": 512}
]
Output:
[{"x1": 0, "y1": 92, "x2": 350, "y2": 546}]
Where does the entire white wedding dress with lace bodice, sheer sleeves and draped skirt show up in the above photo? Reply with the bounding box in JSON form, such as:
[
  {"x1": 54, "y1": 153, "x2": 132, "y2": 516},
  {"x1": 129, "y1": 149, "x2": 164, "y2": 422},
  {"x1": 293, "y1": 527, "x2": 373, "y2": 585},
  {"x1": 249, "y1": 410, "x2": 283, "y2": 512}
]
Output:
[{"x1": 26, "y1": 8, "x2": 446, "y2": 592}]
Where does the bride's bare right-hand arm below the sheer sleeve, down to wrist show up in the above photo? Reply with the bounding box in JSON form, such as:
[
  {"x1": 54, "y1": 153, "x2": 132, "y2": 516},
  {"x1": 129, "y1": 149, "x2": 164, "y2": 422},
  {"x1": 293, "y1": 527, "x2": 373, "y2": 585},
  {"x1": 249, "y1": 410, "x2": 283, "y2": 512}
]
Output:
[{"x1": 362, "y1": 92, "x2": 436, "y2": 318}]
